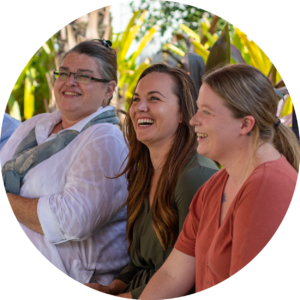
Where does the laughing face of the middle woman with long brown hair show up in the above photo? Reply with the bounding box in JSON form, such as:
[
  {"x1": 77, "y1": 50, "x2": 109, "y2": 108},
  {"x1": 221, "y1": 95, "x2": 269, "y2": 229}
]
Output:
[{"x1": 129, "y1": 72, "x2": 182, "y2": 152}]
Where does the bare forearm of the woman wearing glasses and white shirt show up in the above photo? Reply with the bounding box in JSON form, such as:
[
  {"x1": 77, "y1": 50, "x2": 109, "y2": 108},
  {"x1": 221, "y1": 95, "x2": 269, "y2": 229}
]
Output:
[{"x1": 5, "y1": 193, "x2": 44, "y2": 234}]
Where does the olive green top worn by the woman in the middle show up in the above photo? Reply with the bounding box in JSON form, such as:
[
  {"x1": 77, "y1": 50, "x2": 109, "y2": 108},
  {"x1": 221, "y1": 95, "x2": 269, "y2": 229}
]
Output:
[{"x1": 115, "y1": 153, "x2": 219, "y2": 300}]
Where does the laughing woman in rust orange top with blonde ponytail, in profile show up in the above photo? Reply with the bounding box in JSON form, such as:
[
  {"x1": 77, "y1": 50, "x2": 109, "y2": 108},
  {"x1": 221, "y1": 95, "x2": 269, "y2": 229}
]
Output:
[{"x1": 140, "y1": 64, "x2": 300, "y2": 300}]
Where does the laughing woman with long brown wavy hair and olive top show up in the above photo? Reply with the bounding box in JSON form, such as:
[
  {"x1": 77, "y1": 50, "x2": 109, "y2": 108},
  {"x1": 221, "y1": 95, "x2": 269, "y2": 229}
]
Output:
[{"x1": 85, "y1": 64, "x2": 218, "y2": 300}]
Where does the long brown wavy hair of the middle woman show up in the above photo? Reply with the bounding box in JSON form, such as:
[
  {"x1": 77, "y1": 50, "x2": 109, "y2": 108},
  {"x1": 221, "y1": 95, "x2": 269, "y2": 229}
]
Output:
[{"x1": 117, "y1": 64, "x2": 198, "y2": 252}]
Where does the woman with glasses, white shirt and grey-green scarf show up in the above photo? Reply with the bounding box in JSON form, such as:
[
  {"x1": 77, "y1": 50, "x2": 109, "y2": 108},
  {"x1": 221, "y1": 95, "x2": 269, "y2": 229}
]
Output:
[{"x1": 0, "y1": 40, "x2": 129, "y2": 284}]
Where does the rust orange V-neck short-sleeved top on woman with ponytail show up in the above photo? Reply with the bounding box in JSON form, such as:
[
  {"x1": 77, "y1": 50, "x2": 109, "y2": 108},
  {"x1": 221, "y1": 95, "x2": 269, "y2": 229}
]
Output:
[{"x1": 175, "y1": 155, "x2": 299, "y2": 293}]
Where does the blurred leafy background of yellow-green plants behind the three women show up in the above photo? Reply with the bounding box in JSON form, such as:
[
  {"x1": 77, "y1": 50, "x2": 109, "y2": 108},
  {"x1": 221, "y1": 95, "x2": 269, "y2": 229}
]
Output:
[{"x1": 5, "y1": 0, "x2": 292, "y2": 130}]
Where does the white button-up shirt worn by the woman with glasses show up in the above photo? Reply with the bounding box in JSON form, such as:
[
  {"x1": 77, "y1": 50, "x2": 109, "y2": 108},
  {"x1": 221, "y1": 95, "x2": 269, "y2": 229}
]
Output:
[{"x1": 0, "y1": 106, "x2": 129, "y2": 285}]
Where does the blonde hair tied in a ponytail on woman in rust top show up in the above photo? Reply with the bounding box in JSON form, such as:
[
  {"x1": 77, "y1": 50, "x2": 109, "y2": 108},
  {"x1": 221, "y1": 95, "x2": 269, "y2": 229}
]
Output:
[{"x1": 203, "y1": 64, "x2": 300, "y2": 172}]
